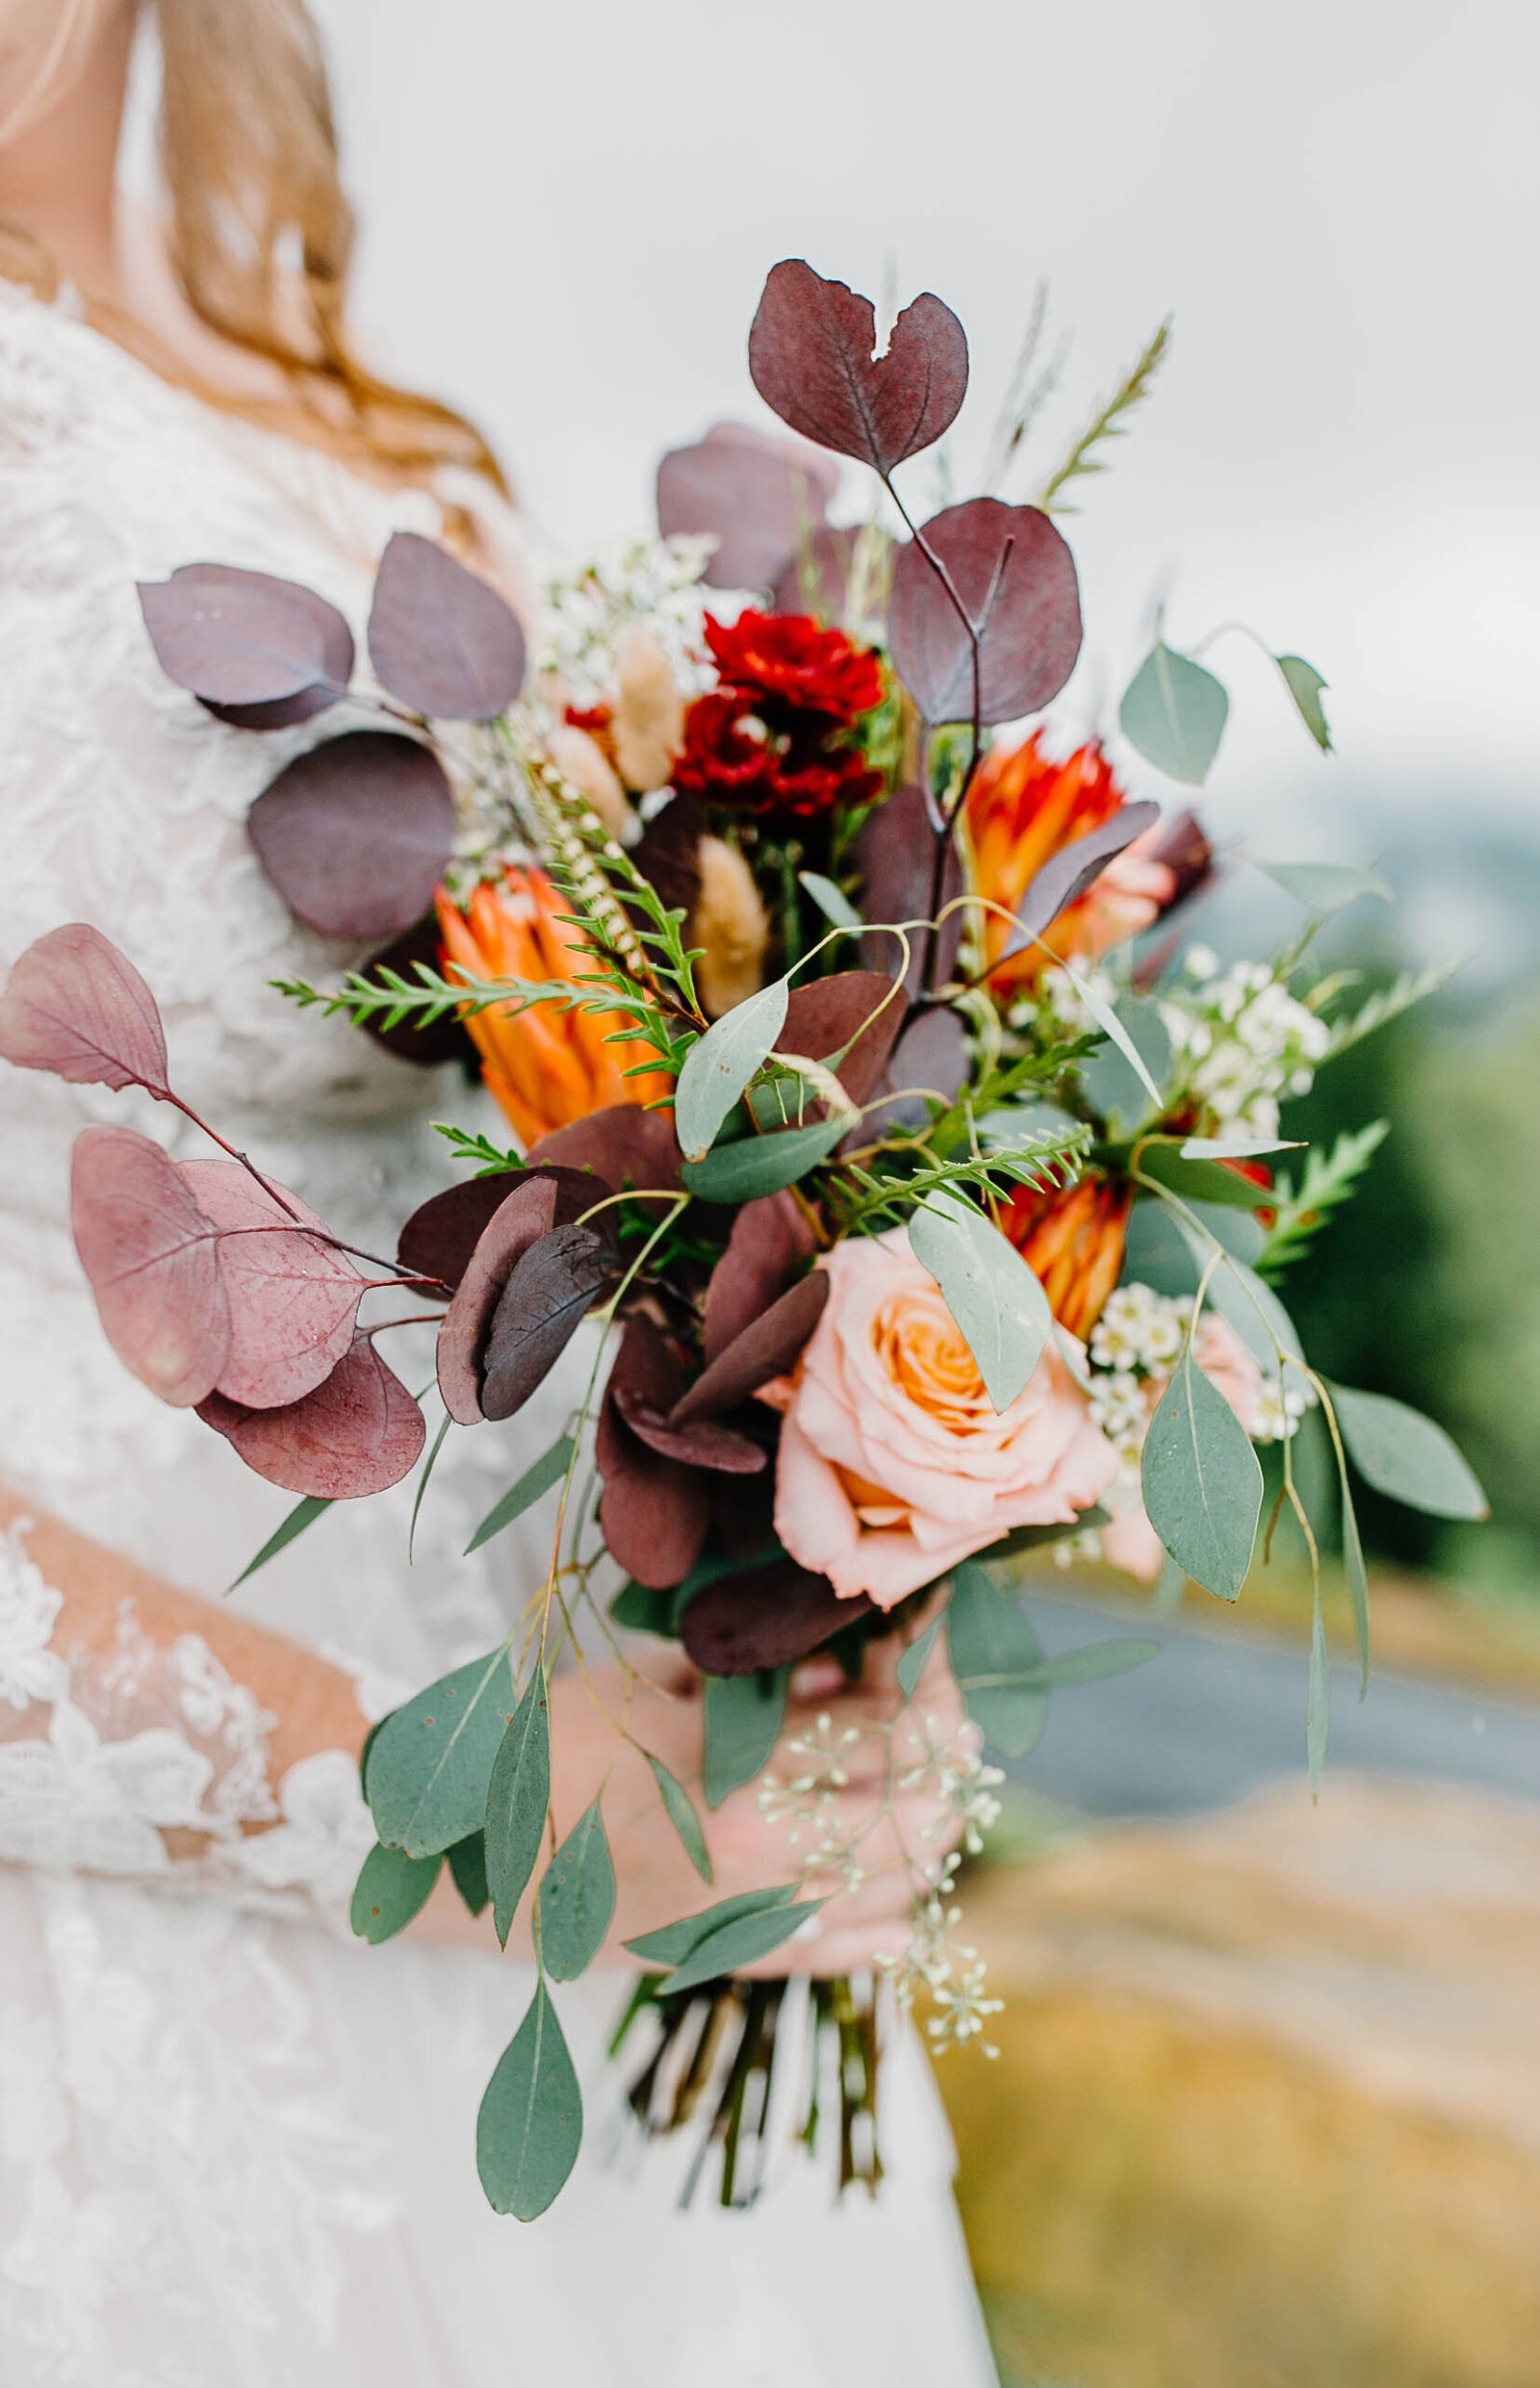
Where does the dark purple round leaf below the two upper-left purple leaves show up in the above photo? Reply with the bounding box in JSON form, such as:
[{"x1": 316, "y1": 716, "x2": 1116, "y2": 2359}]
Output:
[{"x1": 246, "y1": 731, "x2": 453, "y2": 937}]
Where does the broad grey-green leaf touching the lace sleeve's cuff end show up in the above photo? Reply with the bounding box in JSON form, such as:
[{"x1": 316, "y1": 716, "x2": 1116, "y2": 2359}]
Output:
[{"x1": 368, "y1": 1645, "x2": 513, "y2": 1858}]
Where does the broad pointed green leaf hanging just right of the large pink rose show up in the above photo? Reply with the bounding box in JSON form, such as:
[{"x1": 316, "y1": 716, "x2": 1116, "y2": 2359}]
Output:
[{"x1": 1139, "y1": 1345, "x2": 1263, "y2": 1600}]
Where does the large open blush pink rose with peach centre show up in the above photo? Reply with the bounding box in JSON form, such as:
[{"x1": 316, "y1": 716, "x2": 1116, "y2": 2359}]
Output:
[{"x1": 761, "y1": 1227, "x2": 1117, "y2": 1609}]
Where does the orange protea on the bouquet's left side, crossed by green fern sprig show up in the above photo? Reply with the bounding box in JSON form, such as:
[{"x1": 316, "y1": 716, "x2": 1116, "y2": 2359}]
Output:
[{"x1": 439, "y1": 864, "x2": 669, "y2": 1151}]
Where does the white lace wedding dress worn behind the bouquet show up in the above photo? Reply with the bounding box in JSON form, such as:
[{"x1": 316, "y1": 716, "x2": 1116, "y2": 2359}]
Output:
[{"x1": 0, "y1": 292, "x2": 993, "y2": 2388}]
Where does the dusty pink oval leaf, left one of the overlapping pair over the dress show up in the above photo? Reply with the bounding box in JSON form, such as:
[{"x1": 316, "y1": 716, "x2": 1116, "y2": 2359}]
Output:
[{"x1": 69, "y1": 1127, "x2": 229, "y2": 1409}]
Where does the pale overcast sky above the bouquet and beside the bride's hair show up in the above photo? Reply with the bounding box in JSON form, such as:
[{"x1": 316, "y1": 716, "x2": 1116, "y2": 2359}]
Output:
[{"x1": 305, "y1": 0, "x2": 1540, "y2": 853}]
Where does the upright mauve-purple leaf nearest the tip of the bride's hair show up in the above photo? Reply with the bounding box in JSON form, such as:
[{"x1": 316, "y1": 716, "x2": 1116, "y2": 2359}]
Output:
[{"x1": 370, "y1": 530, "x2": 526, "y2": 721}]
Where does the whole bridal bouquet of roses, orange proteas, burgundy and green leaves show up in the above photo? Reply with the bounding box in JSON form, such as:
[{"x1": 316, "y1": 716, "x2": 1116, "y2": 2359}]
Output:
[{"x1": 0, "y1": 263, "x2": 1482, "y2": 2219}]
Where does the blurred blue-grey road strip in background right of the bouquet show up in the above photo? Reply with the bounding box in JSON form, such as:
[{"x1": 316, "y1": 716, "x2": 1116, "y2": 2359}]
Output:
[{"x1": 1010, "y1": 1595, "x2": 1540, "y2": 1817}]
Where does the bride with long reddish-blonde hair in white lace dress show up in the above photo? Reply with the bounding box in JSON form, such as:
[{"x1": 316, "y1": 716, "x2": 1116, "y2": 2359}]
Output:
[{"x1": 0, "y1": 0, "x2": 993, "y2": 2388}]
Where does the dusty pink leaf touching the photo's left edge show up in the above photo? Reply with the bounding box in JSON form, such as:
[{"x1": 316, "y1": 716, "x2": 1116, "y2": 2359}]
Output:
[{"x1": 0, "y1": 919, "x2": 169, "y2": 1101}]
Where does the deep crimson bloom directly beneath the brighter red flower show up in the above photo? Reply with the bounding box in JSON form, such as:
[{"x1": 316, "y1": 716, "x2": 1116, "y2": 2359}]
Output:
[{"x1": 674, "y1": 688, "x2": 881, "y2": 821}]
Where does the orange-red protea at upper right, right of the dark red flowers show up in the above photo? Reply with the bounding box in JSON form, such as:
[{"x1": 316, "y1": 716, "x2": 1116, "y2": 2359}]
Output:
[{"x1": 967, "y1": 731, "x2": 1177, "y2": 998}]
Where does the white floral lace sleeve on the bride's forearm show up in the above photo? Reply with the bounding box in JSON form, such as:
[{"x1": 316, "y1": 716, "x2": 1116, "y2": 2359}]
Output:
[{"x1": 0, "y1": 1521, "x2": 374, "y2": 1913}]
